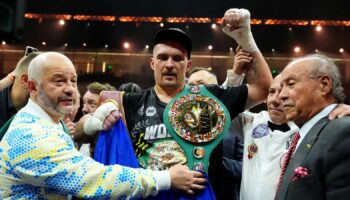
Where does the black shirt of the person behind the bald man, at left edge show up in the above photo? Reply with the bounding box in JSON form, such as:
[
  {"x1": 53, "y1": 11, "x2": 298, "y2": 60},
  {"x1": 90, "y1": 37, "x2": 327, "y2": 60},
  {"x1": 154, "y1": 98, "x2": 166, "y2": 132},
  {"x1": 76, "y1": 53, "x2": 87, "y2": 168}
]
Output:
[{"x1": 0, "y1": 86, "x2": 17, "y2": 128}]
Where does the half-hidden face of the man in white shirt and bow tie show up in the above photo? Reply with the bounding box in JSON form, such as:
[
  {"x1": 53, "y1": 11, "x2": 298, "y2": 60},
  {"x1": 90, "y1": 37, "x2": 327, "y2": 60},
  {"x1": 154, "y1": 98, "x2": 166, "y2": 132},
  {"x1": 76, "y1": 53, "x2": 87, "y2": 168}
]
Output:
[{"x1": 266, "y1": 76, "x2": 287, "y2": 124}]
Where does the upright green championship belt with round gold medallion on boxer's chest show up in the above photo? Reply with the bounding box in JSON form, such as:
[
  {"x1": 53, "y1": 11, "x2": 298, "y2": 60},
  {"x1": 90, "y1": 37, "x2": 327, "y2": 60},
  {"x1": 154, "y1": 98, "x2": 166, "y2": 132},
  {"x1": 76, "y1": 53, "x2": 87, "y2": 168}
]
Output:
[{"x1": 163, "y1": 85, "x2": 231, "y2": 173}]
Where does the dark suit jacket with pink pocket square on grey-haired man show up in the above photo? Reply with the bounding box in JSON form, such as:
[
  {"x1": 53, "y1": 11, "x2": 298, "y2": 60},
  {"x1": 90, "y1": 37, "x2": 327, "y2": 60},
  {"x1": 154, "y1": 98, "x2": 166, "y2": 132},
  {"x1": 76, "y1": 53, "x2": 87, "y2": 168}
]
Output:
[{"x1": 275, "y1": 117, "x2": 350, "y2": 200}]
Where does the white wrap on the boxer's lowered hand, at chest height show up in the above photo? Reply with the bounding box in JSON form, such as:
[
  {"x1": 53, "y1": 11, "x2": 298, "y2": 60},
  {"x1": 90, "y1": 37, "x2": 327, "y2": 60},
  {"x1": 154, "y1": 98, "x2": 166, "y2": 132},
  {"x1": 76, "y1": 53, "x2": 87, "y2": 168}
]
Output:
[{"x1": 84, "y1": 101, "x2": 118, "y2": 135}]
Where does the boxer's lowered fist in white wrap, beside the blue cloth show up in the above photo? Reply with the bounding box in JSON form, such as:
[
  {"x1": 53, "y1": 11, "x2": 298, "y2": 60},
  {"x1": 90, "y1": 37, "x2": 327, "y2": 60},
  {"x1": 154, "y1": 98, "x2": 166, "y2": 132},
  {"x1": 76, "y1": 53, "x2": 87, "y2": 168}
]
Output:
[{"x1": 84, "y1": 101, "x2": 120, "y2": 135}]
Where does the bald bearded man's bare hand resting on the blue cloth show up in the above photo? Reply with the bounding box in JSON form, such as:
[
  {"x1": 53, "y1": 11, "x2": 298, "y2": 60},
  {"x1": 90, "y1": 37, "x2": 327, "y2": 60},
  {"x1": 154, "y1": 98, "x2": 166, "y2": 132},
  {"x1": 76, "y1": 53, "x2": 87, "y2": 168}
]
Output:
[{"x1": 169, "y1": 164, "x2": 207, "y2": 194}]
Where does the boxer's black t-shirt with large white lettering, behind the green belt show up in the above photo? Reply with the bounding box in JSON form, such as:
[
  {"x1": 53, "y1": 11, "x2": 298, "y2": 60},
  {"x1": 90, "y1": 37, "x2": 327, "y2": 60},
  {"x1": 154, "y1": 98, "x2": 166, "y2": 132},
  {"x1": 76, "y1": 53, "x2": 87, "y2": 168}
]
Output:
[{"x1": 123, "y1": 85, "x2": 248, "y2": 199}]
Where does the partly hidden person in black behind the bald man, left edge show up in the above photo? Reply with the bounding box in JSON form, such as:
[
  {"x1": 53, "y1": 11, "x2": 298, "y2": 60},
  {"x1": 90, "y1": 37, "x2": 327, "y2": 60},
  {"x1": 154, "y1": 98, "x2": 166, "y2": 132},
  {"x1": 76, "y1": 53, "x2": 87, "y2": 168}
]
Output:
[{"x1": 0, "y1": 47, "x2": 39, "y2": 131}]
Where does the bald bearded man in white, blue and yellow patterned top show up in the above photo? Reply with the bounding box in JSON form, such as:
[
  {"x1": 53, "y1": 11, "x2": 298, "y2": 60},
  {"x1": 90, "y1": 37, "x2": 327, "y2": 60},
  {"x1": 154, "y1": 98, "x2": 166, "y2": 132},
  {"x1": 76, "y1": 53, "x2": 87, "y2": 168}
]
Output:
[{"x1": 0, "y1": 52, "x2": 205, "y2": 199}]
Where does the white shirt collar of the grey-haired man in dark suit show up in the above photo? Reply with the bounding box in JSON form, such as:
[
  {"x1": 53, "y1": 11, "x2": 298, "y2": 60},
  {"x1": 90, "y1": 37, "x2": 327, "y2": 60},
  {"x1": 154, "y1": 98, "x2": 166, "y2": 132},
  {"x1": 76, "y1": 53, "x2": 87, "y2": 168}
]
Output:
[{"x1": 297, "y1": 104, "x2": 337, "y2": 147}]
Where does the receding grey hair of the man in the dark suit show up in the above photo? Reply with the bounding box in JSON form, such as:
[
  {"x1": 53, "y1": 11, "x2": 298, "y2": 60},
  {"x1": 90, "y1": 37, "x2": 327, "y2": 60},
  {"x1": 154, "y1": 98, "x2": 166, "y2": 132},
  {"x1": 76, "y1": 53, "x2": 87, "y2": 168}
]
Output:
[{"x1": 292, "y1": 54, "x2": 345, "y2": 103}]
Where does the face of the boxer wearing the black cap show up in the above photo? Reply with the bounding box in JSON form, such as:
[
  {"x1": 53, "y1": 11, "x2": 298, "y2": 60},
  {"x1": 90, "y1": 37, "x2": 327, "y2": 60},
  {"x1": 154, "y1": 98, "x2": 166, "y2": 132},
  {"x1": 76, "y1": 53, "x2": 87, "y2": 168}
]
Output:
[{"x1": 150, "y1": 41, "x2": 191, "y2": 90}]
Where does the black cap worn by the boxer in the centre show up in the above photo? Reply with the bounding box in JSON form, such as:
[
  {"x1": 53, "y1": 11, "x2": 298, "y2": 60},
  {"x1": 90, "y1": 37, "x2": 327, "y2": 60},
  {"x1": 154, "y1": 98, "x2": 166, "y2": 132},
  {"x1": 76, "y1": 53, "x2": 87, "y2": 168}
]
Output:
[{"x1": 154, "y1": 28, "x2": 192, "y2": 59}]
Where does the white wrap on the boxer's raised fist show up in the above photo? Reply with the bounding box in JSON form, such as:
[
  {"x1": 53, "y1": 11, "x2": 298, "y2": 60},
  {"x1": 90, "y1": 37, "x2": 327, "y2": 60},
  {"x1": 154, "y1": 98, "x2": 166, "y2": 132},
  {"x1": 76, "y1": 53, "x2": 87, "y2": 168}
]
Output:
[{"x1": 222, "y1": 8, "x2": 259, "y2": 53}]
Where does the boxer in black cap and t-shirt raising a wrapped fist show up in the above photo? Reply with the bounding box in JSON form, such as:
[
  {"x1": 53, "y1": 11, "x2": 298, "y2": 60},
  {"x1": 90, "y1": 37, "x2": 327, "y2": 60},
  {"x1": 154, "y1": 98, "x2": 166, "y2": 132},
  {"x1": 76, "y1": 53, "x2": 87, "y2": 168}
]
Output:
[{"x1": 75, "y1": 9, "x2": 272, "y2": 199}]
